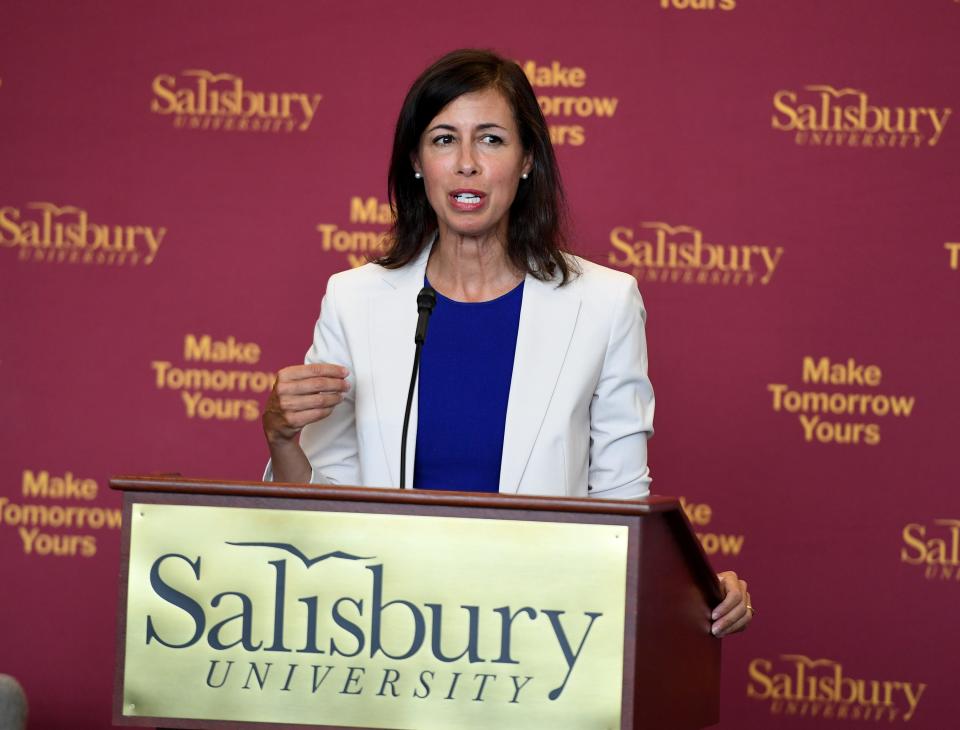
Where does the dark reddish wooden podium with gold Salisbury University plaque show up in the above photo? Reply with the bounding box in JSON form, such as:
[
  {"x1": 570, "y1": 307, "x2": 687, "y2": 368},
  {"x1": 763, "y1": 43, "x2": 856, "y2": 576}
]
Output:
[{"x1": 110, "y1": 477, "x2": 721, "y2": 730}]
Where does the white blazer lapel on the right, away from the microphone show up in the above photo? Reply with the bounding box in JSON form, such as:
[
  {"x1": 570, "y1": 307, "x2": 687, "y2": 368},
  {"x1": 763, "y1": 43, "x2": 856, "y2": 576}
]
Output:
[{"x1": 500, "y1": 275, "x2": 580, "y2": 492}]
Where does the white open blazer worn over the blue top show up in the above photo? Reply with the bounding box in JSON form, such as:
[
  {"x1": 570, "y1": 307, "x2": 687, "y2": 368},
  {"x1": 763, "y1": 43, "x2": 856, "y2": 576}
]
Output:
[{"x1": 264, "y1": 246, "x2": 654, "y2": 499}]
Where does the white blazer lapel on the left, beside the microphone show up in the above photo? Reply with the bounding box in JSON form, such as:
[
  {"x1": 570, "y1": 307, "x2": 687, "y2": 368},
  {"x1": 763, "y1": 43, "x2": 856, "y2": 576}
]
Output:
[{"x1": 367, "y1": 245, "x2": 432, "y2": 487}]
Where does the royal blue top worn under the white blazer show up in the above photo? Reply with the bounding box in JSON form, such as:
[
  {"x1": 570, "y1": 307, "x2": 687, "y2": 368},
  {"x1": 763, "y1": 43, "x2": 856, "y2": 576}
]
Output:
[{"x1": 413, "y1": 282, "x2": 523, "y2": 492}]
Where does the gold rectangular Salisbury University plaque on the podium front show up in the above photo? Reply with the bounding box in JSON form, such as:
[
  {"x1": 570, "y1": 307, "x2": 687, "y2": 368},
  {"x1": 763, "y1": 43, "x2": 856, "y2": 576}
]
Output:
[{"x1": 123, "y1": 503, "x2": 628, "y2": 730}]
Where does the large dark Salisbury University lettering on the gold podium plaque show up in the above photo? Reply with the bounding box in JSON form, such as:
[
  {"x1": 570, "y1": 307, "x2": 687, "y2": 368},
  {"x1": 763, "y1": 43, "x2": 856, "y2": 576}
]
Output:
[{"x1": 145, "y1": 541, "x2": 603, "y2": 704}]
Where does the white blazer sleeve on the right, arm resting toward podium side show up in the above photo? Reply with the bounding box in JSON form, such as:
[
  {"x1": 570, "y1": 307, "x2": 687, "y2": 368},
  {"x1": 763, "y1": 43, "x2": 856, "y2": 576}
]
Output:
[{"x1": 587, "y1": 277, "x2": 654, "y2": 499}]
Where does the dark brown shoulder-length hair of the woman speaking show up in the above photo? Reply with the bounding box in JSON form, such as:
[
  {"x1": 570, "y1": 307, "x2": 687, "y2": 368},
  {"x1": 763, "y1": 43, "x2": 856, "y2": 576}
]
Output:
[{"x1": 376, "y1": 49, "x2": 572, "y2": 284}]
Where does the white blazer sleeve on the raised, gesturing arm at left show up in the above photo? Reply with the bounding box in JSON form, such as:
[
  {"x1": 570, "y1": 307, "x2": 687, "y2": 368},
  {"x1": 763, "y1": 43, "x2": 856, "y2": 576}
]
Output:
[{"x1": 263, "y1": 275, "x2": 361, "y2": 484}]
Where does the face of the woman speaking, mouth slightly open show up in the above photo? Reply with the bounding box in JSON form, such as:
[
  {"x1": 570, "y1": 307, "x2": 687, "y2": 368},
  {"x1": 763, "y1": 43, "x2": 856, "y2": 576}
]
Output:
[{"x1": 413, "y1": 89, "x2": 532, "y2": 243}]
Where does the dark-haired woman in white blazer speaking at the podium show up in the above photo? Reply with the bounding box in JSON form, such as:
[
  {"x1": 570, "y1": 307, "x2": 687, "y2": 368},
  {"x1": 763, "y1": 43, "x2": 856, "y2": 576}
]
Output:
[{"x1": 263, "y1": 50, "x2": 752, "y2": 635}]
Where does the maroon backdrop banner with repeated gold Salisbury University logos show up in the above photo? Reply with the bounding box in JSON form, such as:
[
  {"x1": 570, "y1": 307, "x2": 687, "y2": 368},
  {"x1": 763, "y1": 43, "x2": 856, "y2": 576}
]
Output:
[{"x1": 0, "y1": 0, "x2": 960, "y2": 730}]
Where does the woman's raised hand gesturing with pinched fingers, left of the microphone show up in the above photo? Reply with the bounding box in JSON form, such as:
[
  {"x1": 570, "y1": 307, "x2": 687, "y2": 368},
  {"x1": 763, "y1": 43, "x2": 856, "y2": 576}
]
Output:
[{"x1": 263, "y1": 363, "x2": 350, "y2": 446}]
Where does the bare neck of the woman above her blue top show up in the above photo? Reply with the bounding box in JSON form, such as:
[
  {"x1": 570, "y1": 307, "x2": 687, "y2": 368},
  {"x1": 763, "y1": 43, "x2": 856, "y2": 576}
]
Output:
[{"x1": 427, "y1": 226, "x2": 524, "y2": 302}]
